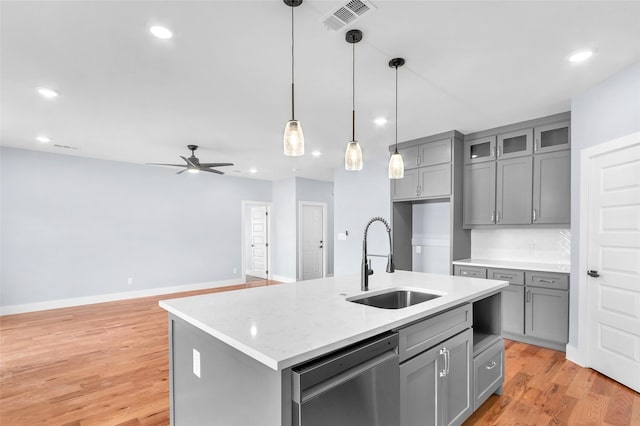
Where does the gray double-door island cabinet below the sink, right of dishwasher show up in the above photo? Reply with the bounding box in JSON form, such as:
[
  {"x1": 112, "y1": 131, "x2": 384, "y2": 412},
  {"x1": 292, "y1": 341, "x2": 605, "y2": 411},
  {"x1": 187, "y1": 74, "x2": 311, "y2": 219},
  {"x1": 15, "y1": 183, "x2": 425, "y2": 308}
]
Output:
[{"x1": 400, "y1": 329, "x2": 473, "y2": 426}]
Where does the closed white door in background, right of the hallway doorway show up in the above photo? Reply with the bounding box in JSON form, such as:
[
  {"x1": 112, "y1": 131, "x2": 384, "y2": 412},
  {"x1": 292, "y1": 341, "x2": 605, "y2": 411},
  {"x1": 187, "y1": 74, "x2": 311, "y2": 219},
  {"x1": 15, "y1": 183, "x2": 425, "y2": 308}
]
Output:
[{"x1": 300, "y1": 204, "x2": 325, "y2": 280}]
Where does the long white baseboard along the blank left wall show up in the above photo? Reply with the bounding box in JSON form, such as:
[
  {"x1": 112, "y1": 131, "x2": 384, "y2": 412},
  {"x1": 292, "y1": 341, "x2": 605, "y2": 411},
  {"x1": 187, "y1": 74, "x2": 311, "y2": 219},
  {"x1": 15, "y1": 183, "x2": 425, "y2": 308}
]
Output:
[{"x1": 0, "y1": 278, "x2": 242, "y2": 316}]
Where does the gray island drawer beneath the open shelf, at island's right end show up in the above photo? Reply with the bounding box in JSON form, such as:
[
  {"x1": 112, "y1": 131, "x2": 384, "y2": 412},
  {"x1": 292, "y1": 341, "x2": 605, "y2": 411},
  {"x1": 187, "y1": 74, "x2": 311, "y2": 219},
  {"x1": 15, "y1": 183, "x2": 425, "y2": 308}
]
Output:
[{"x1": 473, "y1": 339, "x2": 504, "y2": 410}]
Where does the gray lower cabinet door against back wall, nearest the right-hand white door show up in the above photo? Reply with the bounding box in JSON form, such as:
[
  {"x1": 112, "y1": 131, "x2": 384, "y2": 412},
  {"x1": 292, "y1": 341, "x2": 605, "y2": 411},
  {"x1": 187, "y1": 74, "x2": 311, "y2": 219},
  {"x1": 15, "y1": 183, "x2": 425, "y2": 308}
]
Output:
[{"x1": 525, "y1": 286, "x2": 569, "y2": 344}]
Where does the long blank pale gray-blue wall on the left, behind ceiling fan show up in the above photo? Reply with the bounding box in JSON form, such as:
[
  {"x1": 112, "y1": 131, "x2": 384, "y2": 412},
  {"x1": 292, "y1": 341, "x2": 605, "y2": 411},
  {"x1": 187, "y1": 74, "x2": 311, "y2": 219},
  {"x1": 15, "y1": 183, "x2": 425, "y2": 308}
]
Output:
[{"x1": 0, "y1": 148, "x2": 271, "y2": 306}]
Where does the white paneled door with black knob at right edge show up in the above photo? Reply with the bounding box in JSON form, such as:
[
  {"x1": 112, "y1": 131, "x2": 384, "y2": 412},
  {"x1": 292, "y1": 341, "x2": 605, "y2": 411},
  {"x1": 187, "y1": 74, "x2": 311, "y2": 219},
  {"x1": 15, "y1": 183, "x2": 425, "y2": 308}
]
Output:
[{"x1": 581, "y1": 139, "x2": 640, "y2": 392}]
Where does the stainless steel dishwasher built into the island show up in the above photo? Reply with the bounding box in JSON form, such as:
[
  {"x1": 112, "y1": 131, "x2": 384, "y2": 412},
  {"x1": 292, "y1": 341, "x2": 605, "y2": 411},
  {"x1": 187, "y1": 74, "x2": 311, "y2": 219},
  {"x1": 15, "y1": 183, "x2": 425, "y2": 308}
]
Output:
[{"x1": 292, "y1": 333, "x2": 400, "y2": 426}]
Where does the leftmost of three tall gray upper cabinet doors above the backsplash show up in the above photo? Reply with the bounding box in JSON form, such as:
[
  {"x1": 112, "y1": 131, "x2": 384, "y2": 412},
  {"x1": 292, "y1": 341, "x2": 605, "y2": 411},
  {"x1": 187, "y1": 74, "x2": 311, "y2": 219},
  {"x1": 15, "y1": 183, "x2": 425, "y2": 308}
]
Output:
[{"x1": 462, "y1": 161, "x2": 496, "y2": 226}]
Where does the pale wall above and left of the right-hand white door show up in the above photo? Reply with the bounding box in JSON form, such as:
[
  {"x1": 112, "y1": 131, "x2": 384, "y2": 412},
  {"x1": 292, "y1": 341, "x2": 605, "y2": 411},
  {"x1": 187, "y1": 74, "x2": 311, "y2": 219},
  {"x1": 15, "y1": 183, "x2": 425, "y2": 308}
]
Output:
[{"x1": 569, "y1": 63, "x2": 640, "y2": 346}]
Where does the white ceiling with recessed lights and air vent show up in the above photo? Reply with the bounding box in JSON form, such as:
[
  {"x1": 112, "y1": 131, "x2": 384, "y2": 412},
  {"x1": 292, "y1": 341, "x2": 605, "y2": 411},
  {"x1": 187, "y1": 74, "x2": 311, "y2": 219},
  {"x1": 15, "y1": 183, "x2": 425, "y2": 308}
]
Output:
[{"x1": 0, "y1": 0, "x2": 640, "y2": 180}]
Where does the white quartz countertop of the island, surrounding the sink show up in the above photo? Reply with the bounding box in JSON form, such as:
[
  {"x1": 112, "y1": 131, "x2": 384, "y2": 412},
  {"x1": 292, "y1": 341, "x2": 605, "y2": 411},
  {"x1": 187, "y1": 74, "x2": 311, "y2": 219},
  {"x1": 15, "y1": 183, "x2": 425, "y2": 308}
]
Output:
[{"x1": 160, "y1": 271, "x2": 508, "y2": 370}]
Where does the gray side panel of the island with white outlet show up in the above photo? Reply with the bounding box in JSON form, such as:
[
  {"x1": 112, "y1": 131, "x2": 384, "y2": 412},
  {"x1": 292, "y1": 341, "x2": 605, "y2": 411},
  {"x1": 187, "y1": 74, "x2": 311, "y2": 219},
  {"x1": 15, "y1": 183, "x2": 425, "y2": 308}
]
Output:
[{"x1": 169, "y1": 315, "x2": 291, "y2": 426}]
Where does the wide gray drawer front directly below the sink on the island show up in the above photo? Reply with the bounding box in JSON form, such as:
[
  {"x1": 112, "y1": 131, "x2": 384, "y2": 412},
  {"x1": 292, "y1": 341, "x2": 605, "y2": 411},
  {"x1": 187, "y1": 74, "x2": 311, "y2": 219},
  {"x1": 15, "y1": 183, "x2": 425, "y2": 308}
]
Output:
[{"x1": 398, "y1": 303, "x2": 473, "y2": 362}]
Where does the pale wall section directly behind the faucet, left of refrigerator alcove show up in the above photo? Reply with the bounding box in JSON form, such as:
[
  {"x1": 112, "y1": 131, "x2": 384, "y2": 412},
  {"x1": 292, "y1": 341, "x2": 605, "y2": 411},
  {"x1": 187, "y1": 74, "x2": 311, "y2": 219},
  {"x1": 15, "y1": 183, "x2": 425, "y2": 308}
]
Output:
[{"x1": 333, "y1": 160, "x2": 391, "y2": 280}]
